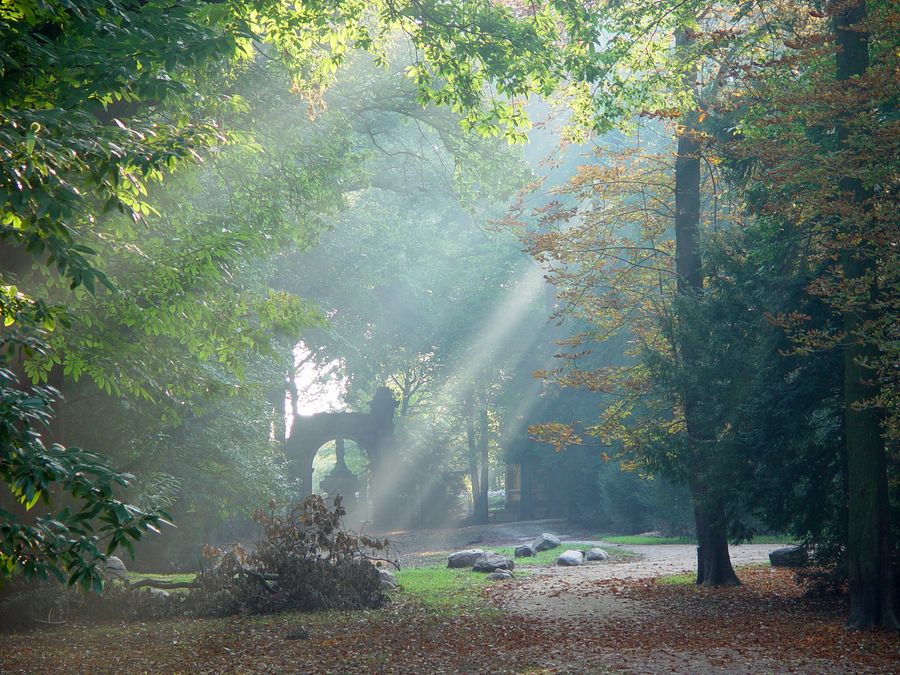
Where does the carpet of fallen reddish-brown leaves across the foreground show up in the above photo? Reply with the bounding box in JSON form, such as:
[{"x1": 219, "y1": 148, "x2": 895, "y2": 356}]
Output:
[{"x1": 2, "y1": 568, "x2": 900, "y2": 673}]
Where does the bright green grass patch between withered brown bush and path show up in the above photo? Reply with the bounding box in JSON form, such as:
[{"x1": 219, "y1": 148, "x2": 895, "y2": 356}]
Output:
[{"x1": 396, "y1": 565, "x2": 488, "y2": 610}]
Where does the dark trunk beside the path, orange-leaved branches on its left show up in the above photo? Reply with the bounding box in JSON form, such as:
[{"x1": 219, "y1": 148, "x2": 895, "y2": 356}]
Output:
[{"x1": 675, "y1": 30, "x2": 740, "y2": 586}]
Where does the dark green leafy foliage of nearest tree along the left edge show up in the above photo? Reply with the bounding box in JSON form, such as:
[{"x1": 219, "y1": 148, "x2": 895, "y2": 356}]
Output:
[{"x1": 0, "y1": 0, "x2": 390, "y2": 586}]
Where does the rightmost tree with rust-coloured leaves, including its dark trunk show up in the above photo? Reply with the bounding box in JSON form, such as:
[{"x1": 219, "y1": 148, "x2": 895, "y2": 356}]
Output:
[{"x1": 720, "y1": 3, "x2": 897, "y2": 626}]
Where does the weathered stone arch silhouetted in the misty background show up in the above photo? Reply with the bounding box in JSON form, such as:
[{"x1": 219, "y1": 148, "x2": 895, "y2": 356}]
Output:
[{"x1": 284, "y1": 387, "x2": 397, "y2": 521}]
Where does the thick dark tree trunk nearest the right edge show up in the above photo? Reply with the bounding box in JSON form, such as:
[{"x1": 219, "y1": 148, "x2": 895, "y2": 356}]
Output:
[{"x1": 834, "y1": 0, "x2": 898, "y2": 628}]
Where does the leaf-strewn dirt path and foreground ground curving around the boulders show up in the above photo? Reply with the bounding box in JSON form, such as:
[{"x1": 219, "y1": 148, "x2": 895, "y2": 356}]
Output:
[{"x1": 0, "y1": 521, "x2": 900, "y2": 675}]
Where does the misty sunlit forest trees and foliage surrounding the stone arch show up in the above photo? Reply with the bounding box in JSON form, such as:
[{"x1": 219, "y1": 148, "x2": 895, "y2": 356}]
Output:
[{"x1": 0, "y1": 1, "x2": 900, "y2": 626}]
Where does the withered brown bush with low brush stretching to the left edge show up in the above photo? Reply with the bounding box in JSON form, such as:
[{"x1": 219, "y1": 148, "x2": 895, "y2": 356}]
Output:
[{"x1": 0, "y1": 495, "x2": 389, "y2": 632}]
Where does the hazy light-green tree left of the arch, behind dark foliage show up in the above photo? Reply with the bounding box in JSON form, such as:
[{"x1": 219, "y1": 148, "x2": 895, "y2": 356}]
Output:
[{"x1": 32, "y1": 64, "x2": 370, "y2": 566}]
